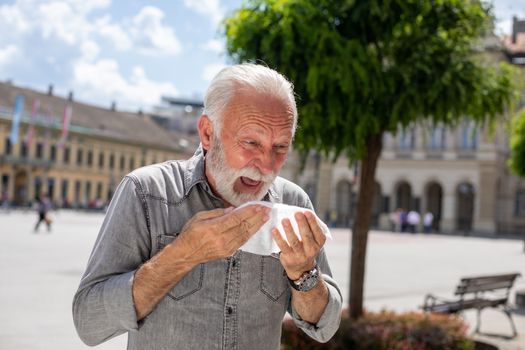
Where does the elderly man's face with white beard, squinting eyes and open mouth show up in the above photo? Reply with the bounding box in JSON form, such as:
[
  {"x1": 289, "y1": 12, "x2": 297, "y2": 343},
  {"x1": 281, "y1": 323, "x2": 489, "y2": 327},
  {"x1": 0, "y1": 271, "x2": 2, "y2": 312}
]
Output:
[{"x1": 206, "y1": 91, "x2": 293, "y2": 206}]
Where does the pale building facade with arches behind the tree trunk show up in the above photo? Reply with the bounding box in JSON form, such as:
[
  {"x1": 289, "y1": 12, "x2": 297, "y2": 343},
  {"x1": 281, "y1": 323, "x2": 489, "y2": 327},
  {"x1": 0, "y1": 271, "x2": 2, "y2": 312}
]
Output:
[{"x1": 288, "y1": 121, "x2": 525, "y2": 234}]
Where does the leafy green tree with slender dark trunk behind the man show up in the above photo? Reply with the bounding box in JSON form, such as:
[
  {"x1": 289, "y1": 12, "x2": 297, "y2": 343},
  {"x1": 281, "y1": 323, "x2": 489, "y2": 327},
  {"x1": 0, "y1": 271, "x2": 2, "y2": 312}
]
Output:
[{"x1": 224, "y1": 0, "x2": 512, "y2": 319}]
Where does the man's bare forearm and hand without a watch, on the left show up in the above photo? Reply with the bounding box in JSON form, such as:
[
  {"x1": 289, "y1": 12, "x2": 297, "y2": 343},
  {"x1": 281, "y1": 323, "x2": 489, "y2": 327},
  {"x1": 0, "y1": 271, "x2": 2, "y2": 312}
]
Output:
[{"x1": 133, "y1": 205, "x2": 270, "y2": 320}]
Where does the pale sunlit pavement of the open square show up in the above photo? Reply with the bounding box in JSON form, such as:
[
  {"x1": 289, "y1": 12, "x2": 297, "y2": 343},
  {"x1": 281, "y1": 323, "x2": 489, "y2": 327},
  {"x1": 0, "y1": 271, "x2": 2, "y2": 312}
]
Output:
[{"x1": 0, "y1": 211, "x2": 525, "y2": 350}]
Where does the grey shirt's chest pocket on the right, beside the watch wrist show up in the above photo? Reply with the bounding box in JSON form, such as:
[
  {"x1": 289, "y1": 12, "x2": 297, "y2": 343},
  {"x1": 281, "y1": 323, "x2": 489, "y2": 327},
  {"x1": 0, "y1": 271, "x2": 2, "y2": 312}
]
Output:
[{"x1": 259, "y1": 256, "x2": 289, "y2": 302}]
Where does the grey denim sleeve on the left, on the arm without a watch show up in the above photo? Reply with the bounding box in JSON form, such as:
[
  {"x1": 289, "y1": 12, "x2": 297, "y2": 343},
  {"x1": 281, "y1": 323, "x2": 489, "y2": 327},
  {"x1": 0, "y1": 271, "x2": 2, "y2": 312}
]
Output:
[{"x1": 73, "y1": 176, "x2": 151, "y2": 346}]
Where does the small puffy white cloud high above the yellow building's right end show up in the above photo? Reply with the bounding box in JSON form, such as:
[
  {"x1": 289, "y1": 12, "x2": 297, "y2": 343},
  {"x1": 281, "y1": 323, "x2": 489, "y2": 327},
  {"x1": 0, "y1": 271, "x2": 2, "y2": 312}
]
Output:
[{"x1": 130, "y1": 6, "x2": 182, "y2": 55}]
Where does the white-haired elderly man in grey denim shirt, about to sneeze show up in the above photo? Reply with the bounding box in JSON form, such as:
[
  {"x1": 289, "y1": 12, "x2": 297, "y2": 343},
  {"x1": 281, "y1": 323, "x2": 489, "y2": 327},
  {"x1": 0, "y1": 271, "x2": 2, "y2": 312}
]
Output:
[{"x1": 73, "y1": 64, "x2": 342, "y2": 350}]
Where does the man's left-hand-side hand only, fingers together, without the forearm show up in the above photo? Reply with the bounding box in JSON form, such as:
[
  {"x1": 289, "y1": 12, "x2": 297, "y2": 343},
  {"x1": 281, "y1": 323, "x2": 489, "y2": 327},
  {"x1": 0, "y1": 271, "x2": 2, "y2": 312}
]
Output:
[{"x1": 176, "y1": 205, "x2": 270, "y2": 264}]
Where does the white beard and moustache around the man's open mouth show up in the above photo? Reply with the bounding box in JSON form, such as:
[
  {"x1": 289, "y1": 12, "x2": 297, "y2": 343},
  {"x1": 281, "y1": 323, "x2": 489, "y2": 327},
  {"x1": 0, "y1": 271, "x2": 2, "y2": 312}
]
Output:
[{"x1": 206, "y1": 137, "x2": 277, "y2": 207}]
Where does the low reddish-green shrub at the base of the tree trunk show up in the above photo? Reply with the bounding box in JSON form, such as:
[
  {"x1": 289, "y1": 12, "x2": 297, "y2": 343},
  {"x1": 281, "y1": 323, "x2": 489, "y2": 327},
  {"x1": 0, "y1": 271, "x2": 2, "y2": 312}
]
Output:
[{"x1": 281, "y1": 311, "x2": 474, "y2": 350}]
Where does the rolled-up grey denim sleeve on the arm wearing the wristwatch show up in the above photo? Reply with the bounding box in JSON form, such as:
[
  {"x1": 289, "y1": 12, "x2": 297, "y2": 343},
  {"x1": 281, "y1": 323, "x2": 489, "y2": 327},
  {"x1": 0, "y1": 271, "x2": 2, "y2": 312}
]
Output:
[{"x1": 290, "y1": 249, "x2": 343, "y2": 343}]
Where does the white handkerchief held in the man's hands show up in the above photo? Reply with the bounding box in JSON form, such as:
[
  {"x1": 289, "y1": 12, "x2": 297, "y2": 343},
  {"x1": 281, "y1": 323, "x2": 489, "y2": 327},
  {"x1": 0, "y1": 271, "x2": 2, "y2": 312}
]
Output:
[{"x1": 235, "y1": 201, "x2": 332, "y2": 255}]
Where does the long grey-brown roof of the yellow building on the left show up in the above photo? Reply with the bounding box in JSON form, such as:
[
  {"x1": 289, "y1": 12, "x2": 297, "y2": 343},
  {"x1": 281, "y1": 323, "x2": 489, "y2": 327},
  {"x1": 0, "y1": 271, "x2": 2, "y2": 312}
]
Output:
[{"x1": 0, "y1": 82, "x2": 184, "y2": 151}]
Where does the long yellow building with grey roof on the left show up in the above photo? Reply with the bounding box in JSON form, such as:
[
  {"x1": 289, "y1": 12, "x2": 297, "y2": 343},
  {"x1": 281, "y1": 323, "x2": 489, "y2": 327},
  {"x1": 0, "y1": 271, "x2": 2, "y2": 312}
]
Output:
[{"x1": 0, "y1": 83, "x2": 191, "y2": 207}]
